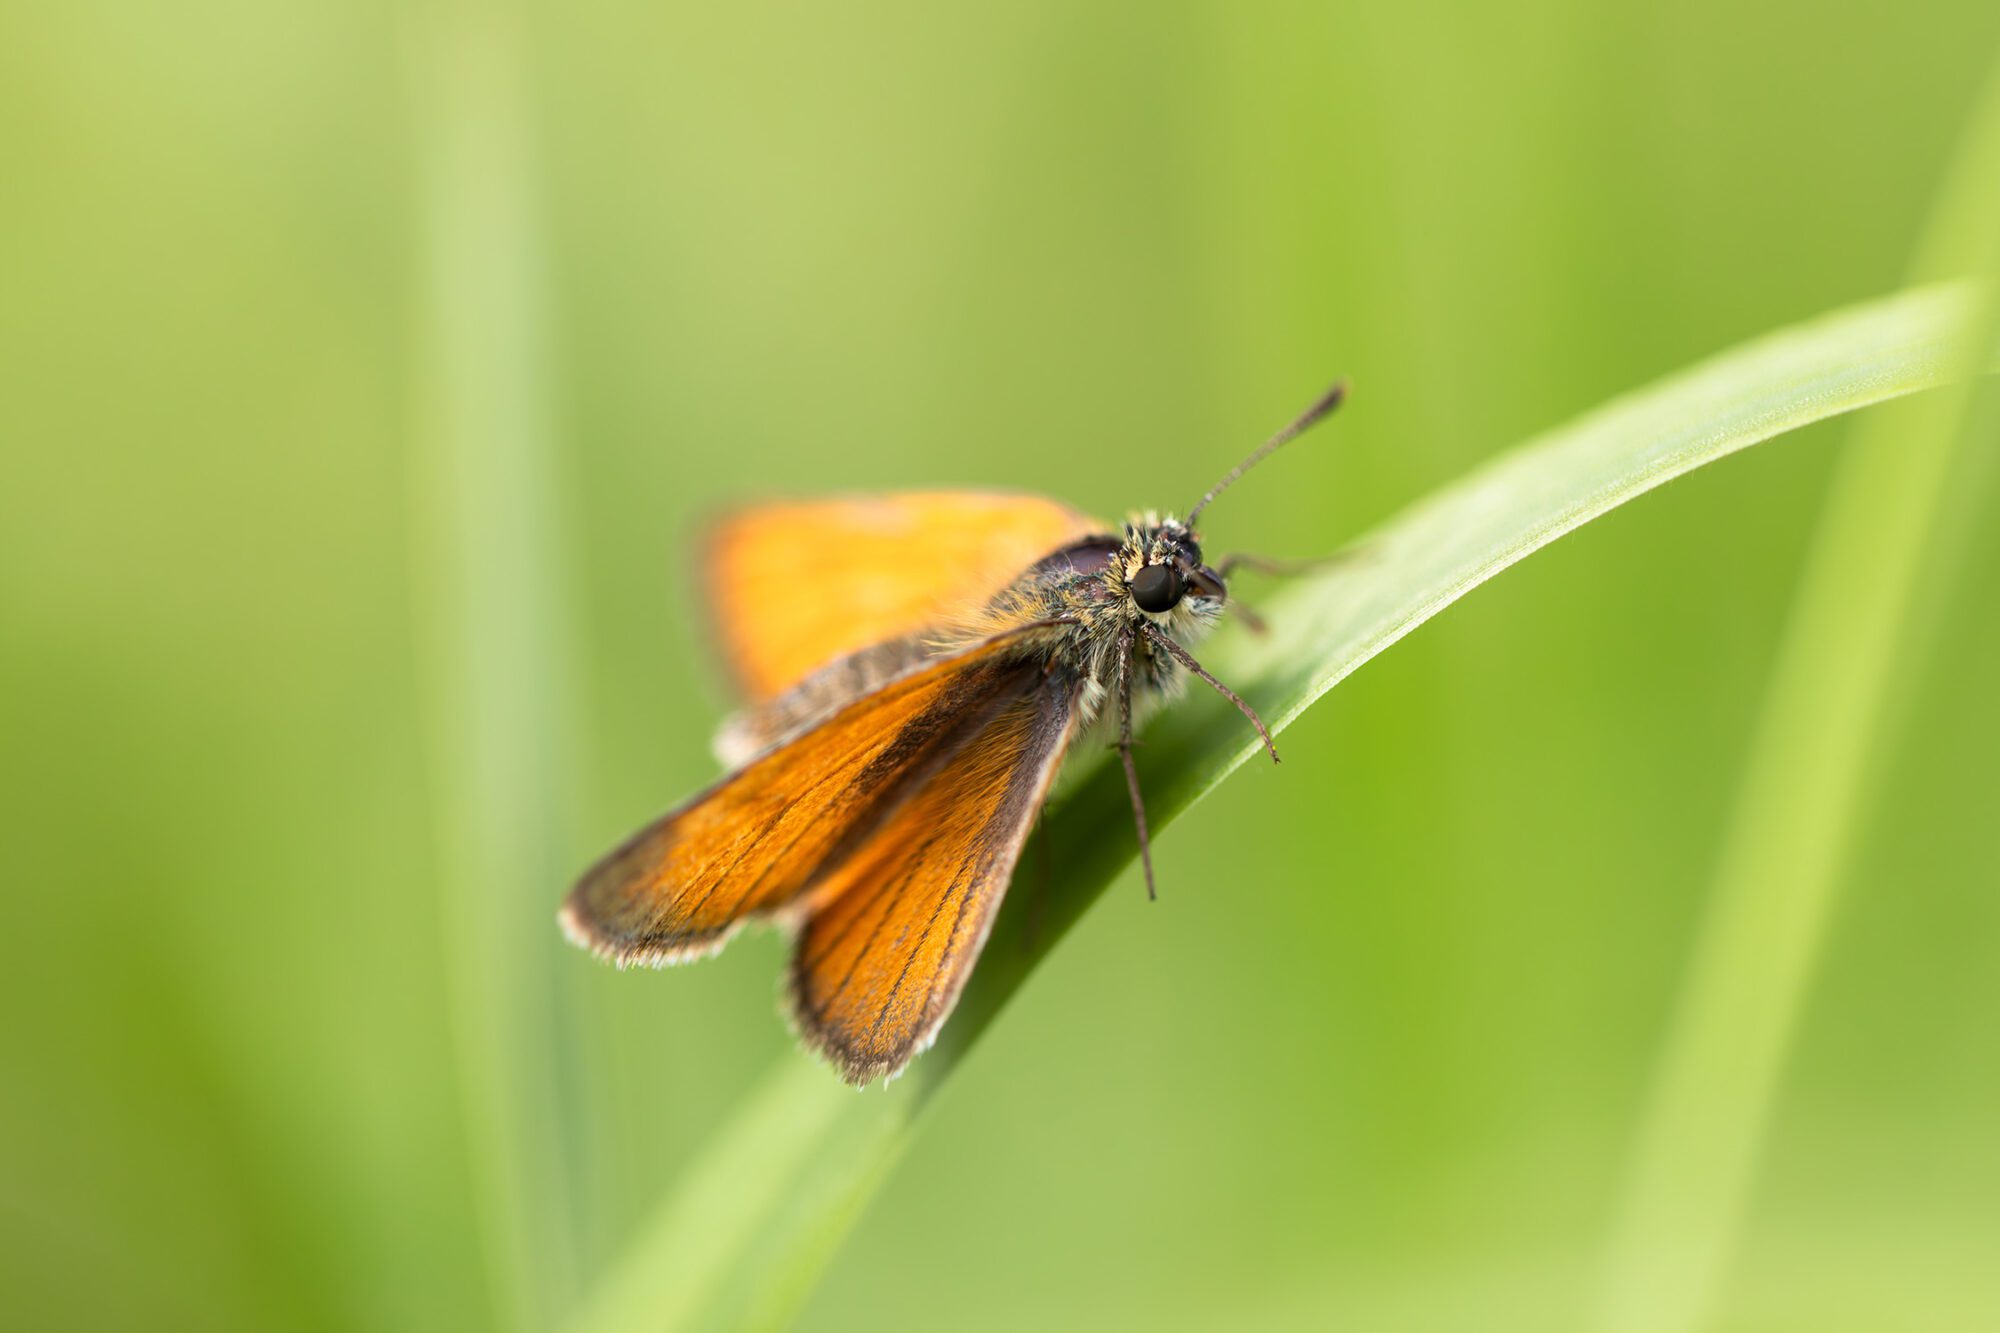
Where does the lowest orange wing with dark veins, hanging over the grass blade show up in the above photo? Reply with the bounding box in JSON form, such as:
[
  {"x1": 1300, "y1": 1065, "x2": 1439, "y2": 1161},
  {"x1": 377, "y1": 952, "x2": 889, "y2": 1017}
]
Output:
[{"x1": 790, "y1": 675, "x2": 1076, "y2": 1083}]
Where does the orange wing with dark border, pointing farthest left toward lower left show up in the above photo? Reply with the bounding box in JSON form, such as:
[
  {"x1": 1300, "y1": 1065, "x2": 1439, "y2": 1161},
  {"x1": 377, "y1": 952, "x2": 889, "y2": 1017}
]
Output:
[{"x1": 562, "y1": 638, "x2": 1042, "y2": 965}]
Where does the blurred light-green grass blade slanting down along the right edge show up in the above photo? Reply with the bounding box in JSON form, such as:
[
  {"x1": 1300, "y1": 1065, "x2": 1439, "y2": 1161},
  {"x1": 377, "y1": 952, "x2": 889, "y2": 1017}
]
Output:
[{"x1": 1598, "y1": 65, "x2": 2000, "y2": 1333}]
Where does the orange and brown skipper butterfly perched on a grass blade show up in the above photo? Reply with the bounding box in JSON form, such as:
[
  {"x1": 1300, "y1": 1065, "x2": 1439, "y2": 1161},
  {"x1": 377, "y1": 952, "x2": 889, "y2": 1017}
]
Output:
[{"x1": 560, "y1": 384, "x2": 1346, "y2": 1085}]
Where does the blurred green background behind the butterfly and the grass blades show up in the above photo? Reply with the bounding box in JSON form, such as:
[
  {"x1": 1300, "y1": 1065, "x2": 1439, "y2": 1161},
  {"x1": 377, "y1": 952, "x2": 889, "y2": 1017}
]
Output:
[{"x1": 0, "y1": 0, "x2": 2000, "y2": 1329}]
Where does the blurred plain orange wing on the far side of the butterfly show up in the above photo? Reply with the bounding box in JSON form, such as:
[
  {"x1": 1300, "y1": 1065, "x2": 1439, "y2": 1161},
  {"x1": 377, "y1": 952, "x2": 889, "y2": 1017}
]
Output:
[{"x1": 706, "y1": 490, "x2": 1106, "y2": 703}]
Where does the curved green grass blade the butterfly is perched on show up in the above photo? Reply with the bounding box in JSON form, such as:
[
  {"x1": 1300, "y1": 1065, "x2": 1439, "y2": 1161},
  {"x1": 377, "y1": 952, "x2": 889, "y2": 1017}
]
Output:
[{"x1": 574, "y1": 288, "x2": 1992, "y2": 1333}]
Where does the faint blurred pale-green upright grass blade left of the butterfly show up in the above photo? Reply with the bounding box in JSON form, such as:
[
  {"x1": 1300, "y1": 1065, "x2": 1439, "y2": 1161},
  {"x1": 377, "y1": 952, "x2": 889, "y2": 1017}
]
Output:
[{"x1": 410, "y1": 0, "x2": 572, "y2": 1329}]
